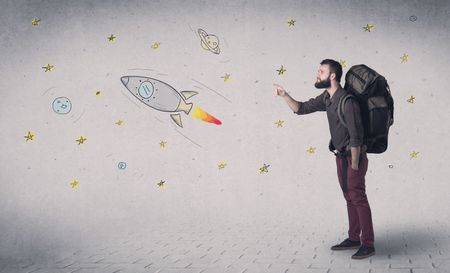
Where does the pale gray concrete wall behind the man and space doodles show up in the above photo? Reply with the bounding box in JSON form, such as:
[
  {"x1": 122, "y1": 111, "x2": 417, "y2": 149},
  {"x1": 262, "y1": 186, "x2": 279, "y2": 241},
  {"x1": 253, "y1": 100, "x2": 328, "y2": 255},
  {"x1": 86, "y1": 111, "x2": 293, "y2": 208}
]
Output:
[{"x1": 0, "y1": 0, "x2": 450, "y2": 258}]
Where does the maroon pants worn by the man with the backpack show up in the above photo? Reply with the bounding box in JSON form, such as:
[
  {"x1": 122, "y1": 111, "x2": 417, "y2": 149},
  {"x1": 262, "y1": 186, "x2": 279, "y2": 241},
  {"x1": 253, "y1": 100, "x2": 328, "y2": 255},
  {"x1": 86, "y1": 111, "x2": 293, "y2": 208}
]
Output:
[{"x1": 336, "y1": 153, "x2": 374, "y2": 246}]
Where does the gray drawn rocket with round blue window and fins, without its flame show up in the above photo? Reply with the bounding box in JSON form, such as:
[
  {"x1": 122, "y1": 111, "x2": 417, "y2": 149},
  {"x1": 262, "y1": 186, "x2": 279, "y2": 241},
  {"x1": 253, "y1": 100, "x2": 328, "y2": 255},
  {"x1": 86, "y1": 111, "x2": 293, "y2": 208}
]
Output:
[{"x1": 120, "y1": 76, "x2": 198, "y2": 127}]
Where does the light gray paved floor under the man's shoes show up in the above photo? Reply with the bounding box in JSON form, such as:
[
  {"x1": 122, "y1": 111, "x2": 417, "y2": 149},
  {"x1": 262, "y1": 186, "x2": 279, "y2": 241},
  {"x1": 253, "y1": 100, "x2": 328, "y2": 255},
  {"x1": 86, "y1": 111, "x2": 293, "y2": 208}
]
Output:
[{"x1": 0, "y1": 219, "x2": 450, "y2": 273}]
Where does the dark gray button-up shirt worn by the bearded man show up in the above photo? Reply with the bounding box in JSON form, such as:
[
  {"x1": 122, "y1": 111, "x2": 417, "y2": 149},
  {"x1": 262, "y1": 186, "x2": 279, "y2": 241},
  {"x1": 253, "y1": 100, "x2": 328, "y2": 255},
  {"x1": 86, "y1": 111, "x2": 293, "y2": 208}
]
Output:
[{"x1": 295, "y1": 87, "x2": 364, "y2": 151}]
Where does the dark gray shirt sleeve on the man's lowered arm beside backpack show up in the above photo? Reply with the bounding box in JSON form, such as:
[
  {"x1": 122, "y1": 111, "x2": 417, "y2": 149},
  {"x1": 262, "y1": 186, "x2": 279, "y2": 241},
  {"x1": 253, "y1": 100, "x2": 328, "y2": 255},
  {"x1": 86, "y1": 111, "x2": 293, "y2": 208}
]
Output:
[{"x1": 344, "y1": 99, "x2": 364, "y2": 147}]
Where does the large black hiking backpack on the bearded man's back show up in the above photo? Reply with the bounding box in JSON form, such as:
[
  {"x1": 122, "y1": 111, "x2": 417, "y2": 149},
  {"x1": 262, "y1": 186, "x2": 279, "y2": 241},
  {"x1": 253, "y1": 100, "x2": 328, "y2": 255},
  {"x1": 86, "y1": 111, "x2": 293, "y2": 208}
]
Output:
[{"x1": 338, "y1": 64, "x2": 394, "y2": 154}]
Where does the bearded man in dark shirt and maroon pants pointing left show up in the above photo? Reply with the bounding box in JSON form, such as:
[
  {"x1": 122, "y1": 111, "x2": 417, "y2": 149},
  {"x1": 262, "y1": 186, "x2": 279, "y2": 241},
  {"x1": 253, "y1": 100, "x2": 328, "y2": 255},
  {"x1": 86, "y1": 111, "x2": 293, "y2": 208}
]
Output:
[{"x1": 274, "y1": 59, "x2": 375, "y2": 259}]
